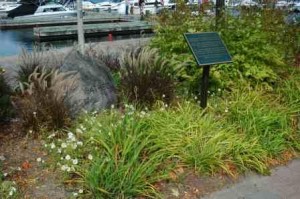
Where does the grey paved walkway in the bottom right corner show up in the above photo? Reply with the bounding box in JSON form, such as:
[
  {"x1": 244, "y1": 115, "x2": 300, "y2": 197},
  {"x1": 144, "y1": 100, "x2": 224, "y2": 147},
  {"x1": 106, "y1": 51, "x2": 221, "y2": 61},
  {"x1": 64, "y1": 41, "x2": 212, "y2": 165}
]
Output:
[{"x1": 204, "y1": 159, "x2": 300, "y2": 199}]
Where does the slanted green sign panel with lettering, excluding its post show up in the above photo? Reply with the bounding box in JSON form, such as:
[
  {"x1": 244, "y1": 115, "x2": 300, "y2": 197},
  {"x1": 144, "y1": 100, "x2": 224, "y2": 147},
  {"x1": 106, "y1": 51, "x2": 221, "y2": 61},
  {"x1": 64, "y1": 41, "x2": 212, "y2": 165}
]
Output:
[{"x1": 184, "y1": 32, "x2": 231, "y2": 66}]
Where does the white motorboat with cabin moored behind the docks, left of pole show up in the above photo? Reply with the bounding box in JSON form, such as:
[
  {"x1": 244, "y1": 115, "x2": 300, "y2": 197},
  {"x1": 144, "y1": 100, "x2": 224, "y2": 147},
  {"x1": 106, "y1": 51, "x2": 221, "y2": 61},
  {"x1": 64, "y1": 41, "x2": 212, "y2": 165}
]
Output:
[{"x1": 14, "y1": 4, "x2": 77, "y2": 20}]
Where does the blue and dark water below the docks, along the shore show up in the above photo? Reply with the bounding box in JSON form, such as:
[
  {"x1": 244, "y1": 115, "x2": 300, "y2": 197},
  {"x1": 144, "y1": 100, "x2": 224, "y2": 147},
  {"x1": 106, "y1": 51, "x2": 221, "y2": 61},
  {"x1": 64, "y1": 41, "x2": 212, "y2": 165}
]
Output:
[{"x1": 0, "y1": 29, "x2": 151, "y2": 57}]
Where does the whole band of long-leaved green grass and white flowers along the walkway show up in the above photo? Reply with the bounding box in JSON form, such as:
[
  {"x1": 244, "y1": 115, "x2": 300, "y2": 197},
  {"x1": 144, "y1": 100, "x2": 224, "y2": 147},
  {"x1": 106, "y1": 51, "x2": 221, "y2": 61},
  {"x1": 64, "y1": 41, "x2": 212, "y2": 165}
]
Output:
[{"x1": 48, "y1": 80, "x2": 300, "y2": 198}]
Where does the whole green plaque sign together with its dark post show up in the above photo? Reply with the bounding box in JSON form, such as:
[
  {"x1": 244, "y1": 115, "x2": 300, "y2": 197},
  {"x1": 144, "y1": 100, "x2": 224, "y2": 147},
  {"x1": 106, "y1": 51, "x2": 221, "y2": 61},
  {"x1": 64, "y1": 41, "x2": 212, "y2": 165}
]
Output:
[{"x1": 184, "y1": 32, "x2": 231, "y2": 108}]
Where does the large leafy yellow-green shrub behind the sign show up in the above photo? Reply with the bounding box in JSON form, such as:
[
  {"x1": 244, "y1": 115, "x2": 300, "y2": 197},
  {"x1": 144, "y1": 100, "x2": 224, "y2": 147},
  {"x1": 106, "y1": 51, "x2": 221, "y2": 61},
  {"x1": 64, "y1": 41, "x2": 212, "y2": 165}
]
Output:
[{"x1": 151, "y1": 7, "x2": 299, "y2": 93}]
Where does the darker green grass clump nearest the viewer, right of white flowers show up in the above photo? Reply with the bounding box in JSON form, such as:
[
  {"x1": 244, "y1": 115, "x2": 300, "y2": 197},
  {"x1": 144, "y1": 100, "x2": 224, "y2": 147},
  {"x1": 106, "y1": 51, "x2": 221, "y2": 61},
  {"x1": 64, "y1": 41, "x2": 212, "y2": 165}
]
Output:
[{"x1": 85, "y1": 112, "x2": 163, "y2": 198}]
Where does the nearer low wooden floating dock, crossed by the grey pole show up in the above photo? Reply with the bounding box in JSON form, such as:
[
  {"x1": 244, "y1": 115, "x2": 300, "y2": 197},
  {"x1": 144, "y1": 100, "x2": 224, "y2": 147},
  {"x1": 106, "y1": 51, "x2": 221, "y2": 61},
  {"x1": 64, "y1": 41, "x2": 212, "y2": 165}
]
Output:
[{"x1": 34, "y1": 21, "x2": 152, "y2": 41}]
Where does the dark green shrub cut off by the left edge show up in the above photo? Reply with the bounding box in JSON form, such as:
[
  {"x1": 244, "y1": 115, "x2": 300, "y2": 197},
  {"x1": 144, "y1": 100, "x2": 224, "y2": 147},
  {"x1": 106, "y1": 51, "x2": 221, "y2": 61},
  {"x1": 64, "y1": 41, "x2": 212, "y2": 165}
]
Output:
[{"x1": 0, "y1": 67, "x2": 14, "y2": 122}]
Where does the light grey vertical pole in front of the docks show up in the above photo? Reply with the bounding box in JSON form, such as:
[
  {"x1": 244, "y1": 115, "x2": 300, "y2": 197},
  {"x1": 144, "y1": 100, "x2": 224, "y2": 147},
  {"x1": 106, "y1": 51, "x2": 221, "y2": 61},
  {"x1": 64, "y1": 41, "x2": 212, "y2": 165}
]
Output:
[{"x1": 76, "y1": 0, "x2": 84, "y2": 55}]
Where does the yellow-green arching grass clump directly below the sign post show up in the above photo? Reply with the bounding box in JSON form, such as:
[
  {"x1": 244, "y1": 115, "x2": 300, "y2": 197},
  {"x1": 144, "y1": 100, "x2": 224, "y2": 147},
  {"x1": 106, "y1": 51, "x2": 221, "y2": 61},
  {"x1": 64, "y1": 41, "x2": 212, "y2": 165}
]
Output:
[{"x1": 145, "y1": 102, "x2": 268, "y2": 176}]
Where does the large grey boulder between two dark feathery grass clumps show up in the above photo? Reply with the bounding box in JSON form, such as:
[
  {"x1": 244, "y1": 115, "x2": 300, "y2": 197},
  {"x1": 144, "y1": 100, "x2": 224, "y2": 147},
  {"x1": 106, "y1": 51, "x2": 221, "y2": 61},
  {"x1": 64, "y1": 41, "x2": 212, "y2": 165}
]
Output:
[{"x1": 60, "y1": 50, "x2": 117, "y2": 116}]
